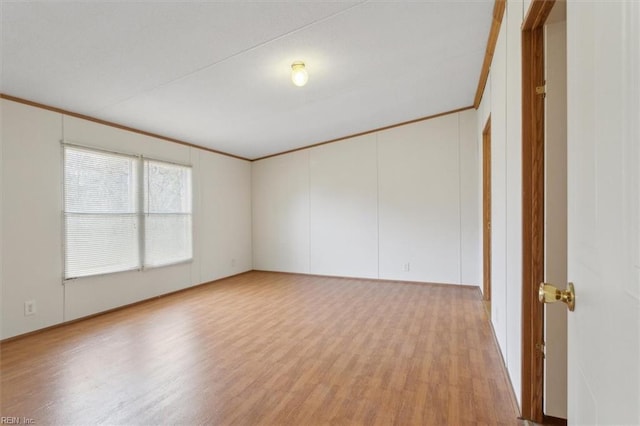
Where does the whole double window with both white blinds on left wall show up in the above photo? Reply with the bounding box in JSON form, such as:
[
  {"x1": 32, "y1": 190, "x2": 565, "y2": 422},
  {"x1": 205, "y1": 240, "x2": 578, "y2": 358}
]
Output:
[{"x1": 64, "y1": 145, "x2": 193, "y2": 279}]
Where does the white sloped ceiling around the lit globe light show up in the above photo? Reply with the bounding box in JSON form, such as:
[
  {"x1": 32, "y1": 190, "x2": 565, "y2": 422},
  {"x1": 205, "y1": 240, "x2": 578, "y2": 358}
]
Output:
[{"x1": 0, "y1": 0, "x2": 494, "y2": 159}]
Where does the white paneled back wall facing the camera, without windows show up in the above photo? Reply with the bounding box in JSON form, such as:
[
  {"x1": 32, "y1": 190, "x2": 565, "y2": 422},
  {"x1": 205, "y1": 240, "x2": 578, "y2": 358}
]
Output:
[{"x1": 252, "y1": 110, "x2": 480, "y2": 285}]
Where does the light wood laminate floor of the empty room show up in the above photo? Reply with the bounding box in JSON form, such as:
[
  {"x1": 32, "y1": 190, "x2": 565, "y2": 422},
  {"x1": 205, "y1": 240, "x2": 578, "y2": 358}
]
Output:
[{"x1": 0, "y1": 272, "x2": 519, "y2": 425}]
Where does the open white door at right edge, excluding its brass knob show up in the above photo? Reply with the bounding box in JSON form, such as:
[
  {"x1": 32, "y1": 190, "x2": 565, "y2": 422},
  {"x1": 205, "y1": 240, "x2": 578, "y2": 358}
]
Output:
[{"x1": 567, "y1": 0, "x2": 640, "y2": 425}]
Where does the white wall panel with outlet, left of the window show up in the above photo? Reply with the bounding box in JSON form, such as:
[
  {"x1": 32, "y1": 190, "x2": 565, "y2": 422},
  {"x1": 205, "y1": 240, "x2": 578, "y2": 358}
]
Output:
[{"x1": 0, "y1": 100, "x2": 64, "y2": 338}]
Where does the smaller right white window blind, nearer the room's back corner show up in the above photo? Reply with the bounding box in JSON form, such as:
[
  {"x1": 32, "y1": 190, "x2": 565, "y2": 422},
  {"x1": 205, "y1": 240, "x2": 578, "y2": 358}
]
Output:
[{"x1": 144, "y1": 159, "x2": 192, "y2": 266}]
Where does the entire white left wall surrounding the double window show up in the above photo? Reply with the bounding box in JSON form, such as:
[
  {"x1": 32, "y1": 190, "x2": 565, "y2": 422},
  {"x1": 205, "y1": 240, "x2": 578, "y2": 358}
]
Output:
[{"x1": 1, "y1": 100, "x2": 252, "y2": 338}]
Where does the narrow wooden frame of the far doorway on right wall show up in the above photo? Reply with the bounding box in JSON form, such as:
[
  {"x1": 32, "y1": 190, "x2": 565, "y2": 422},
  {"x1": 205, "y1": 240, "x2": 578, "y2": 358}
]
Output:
[{"x1": 482, "y1": 115, "x2": 491, "y2": 302}]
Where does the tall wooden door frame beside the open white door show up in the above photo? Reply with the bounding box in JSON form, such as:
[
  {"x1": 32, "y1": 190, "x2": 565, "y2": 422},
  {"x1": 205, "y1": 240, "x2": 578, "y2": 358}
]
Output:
[{"x1": 522, "y1": 0, "x2": 555, "y2": 423}]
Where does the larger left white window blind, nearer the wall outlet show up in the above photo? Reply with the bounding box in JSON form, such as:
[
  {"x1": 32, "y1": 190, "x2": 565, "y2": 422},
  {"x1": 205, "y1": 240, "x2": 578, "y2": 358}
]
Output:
[{"x1": 64, "y1": 146, "x2": 140, "y2": 278}]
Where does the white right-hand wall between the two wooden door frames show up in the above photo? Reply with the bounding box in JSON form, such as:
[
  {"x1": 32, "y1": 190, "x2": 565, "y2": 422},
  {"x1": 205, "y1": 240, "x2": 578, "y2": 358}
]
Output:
[{"x1": 476, "y1": 0, "x2": 523, "y2": 410}]
